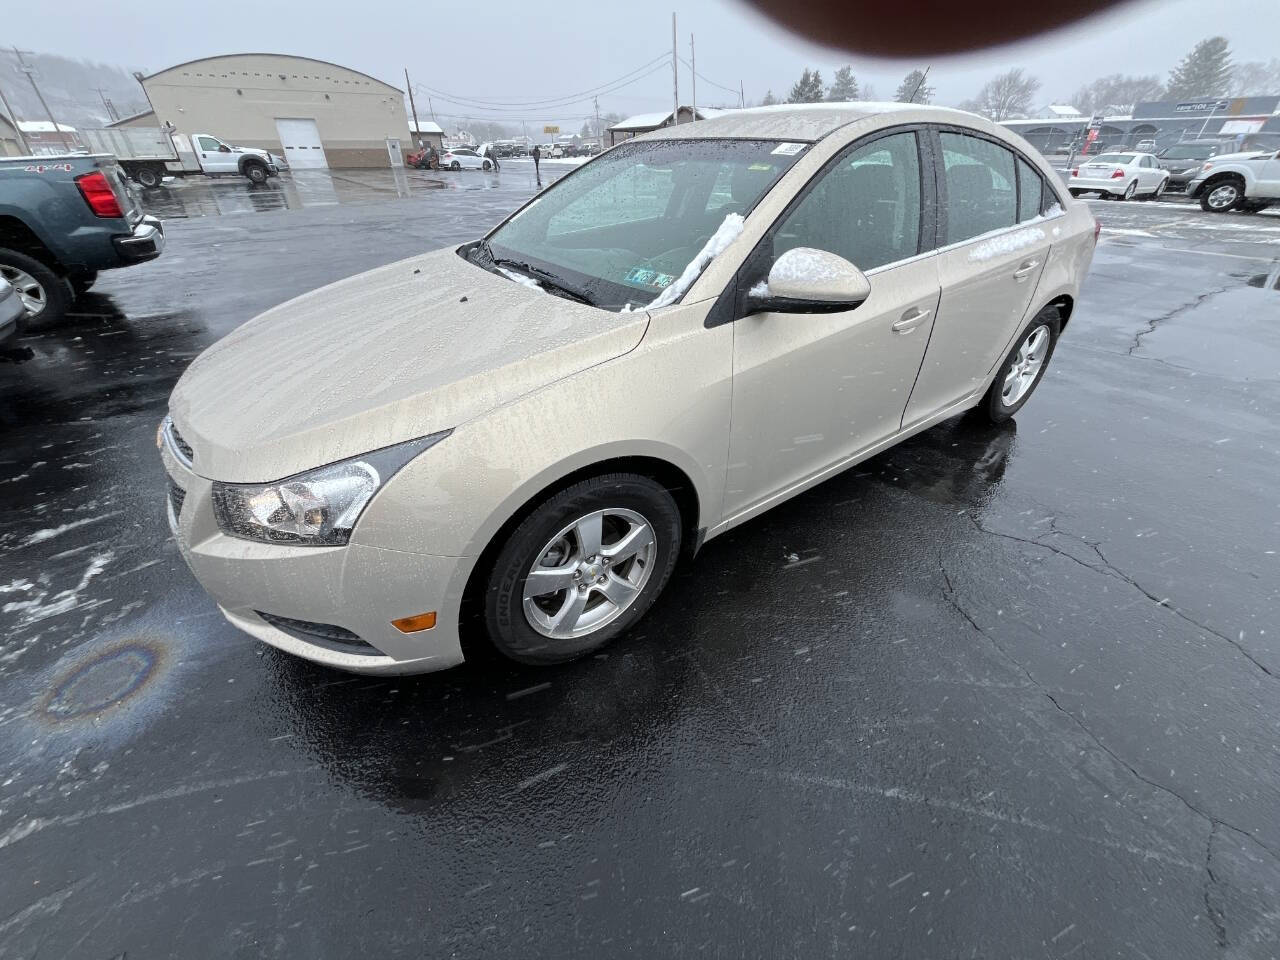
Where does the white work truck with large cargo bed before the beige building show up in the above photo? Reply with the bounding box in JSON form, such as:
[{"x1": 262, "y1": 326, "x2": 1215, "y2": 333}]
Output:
[{"x1": 81, "y1": 127, "x2": 285, "y2": 187}]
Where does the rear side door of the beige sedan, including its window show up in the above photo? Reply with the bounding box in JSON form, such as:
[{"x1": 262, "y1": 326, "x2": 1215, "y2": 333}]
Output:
[{"x1": 902, "y1": 128, "x2": 1061, "y2": 426}]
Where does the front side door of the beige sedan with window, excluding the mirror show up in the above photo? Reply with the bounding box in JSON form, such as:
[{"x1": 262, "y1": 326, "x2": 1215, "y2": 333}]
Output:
[{"x1": 724, "y1": 128, "x2": 938, "y2": 517}]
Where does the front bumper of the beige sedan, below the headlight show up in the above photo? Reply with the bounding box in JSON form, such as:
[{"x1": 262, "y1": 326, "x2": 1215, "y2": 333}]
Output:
[{"x1": 161, "y1": 436, "x2": 472, "y2": 675}]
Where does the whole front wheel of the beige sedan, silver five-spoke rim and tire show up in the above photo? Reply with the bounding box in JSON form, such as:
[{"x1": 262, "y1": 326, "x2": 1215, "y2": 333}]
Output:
[{"x1": 484, "y1": 474, "x2": 681, "y2": 664}]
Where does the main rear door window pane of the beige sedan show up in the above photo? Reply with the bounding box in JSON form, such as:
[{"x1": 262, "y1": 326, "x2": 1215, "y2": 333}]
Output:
[{"x1": 940, "y1": 133, "x2": 1018, "y2": 243}]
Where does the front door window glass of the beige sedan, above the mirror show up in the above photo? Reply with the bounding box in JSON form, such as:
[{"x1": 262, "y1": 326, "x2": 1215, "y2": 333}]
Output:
[{"x1": 773, "y1": 133, "x2": 920, "y2": 270}]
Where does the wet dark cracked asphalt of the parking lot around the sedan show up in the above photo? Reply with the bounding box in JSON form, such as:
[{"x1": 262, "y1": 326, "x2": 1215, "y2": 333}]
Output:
[{"x1": 0, "y1": 164, "x2": 1280, "y2": 960}]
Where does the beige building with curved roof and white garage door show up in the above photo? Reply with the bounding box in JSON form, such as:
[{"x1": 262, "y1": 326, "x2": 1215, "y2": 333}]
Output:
[{"x1": 113, "y1": 54, "x2": 412, "y2": 170}]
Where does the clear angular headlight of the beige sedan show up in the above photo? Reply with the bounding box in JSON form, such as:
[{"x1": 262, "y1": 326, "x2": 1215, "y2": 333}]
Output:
[{"x1": 212, "y1": 430, "x2": 453, "y2": 547}]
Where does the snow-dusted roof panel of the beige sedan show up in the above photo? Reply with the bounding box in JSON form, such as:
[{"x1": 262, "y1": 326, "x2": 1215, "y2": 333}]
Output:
[{"x1": 636, "y1": 100, "x2": 979, "y2": 142}]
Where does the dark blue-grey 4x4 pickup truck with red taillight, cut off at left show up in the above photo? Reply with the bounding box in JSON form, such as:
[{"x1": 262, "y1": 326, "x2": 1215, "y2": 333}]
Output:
[{"x1": 0, "y1": 154, "x2": 164, "y2": 323}]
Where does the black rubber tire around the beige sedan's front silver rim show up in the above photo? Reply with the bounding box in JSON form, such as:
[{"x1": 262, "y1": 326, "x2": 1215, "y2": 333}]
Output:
[{"x1": 483, "y1": 474, "x2": 681, "y2": 666}]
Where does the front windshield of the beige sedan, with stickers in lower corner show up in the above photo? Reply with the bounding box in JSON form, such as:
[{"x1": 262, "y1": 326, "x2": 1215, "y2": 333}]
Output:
[{"x1": 488, "y1": 140, "x2": 808, "y2": 308}]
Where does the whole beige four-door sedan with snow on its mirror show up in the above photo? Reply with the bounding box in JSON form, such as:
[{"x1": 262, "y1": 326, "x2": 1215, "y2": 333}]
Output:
[{"x1": 160, "y1": 102, "x2": 1097, "y2": 673}]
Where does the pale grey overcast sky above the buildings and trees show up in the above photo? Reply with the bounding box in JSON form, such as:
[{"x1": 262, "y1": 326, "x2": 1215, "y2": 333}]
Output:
[{"x1": 4, "y1": 0, "x2": 1280, "y2": 128}]
